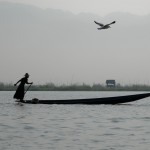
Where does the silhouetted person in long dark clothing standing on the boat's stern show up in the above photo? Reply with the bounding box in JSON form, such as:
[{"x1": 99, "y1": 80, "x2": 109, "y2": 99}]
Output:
[{"x1": 14, "y1": 73, "x2": 33, "y2": 102}]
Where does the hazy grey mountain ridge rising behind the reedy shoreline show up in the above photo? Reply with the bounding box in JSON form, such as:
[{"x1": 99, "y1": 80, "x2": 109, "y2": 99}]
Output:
[{"x1": 0, "y1": 2, "x2": 150, "y2": 83}]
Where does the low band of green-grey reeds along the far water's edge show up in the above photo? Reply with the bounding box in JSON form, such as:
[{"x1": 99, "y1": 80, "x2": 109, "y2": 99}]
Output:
[{"x1": 0, "y1": 82, "x2": 150, "y2": 91}]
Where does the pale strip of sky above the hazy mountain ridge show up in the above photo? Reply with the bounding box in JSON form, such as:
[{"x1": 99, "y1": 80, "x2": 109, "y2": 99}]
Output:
[{"x1": 0, "y1": 0, "x2": 150, "y2": 15}]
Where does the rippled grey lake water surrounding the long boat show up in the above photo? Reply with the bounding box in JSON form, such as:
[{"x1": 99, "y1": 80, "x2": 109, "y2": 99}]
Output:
[{"x1": 0, "y1": 92, "x2": 150, "y2": 150}]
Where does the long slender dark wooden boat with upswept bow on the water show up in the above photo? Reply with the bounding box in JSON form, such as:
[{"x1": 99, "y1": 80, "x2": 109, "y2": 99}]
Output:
[{"x1": 23, "y1": 93, "x2": 150, "y2": 105}]
